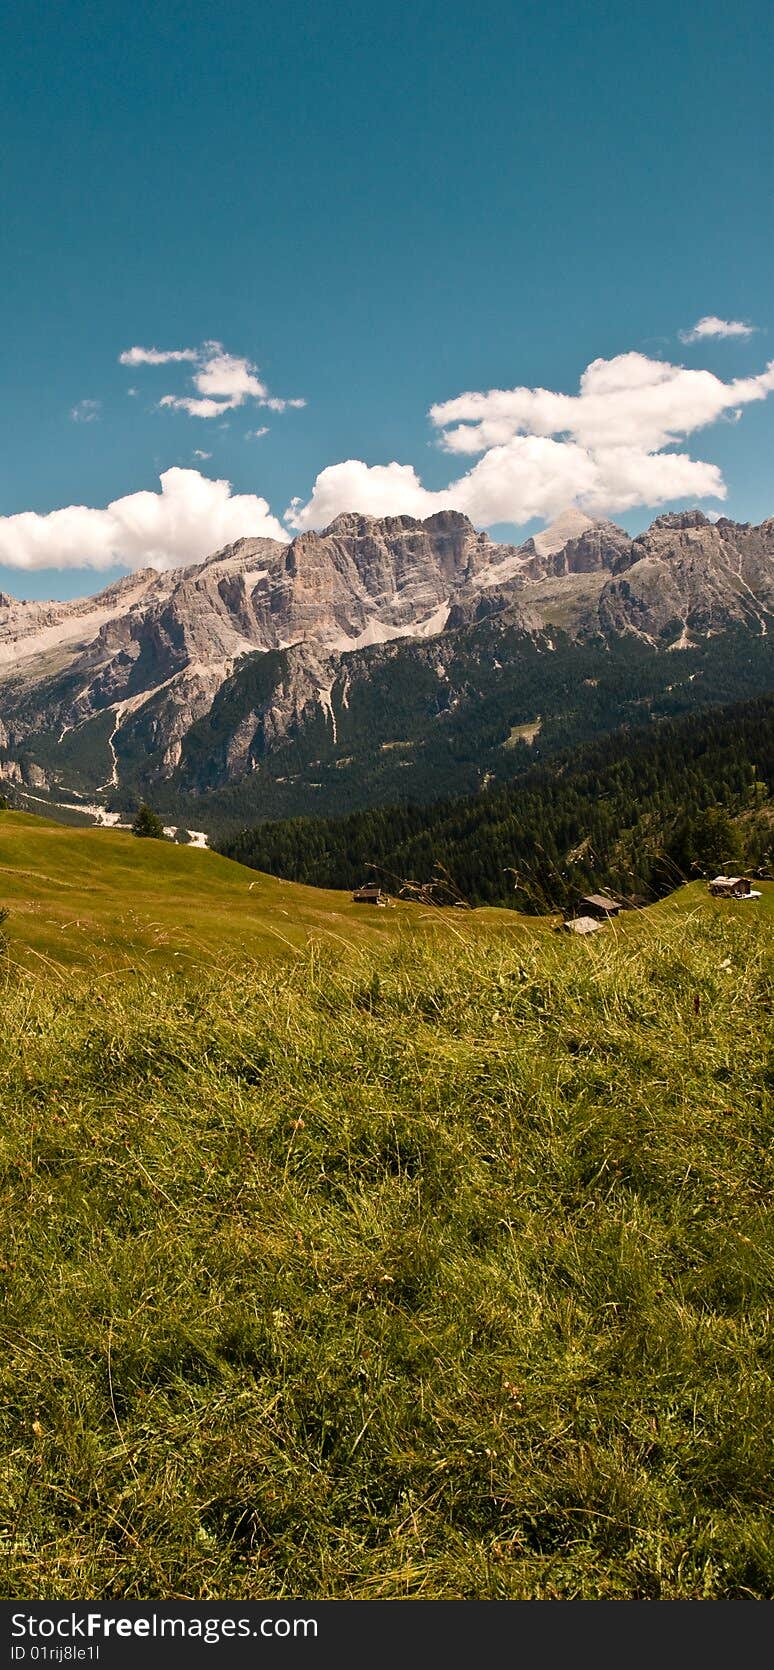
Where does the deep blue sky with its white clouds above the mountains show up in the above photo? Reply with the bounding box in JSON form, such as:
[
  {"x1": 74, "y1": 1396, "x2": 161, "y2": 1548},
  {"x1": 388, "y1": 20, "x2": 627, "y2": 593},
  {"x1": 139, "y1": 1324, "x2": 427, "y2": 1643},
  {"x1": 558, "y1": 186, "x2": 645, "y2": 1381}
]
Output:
[{"x1": 0, "y1": 0, "x2": 774, "y2": 596}]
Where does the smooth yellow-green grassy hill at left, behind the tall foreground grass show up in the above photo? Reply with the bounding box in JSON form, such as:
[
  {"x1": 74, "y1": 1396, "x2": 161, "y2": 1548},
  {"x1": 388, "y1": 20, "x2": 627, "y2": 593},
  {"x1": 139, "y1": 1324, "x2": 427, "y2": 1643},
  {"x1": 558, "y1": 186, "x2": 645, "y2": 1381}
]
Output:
[{"x1": 0, "y1": 812, "x2": 508, "y2": 969}]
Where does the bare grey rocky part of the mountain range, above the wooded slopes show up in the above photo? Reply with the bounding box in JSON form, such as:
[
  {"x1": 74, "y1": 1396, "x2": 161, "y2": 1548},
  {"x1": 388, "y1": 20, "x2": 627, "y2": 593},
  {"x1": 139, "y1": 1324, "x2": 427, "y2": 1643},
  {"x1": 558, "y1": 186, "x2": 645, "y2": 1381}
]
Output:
[{"x1": 0, "y1": 509, "x2": 774, "y2": 824}]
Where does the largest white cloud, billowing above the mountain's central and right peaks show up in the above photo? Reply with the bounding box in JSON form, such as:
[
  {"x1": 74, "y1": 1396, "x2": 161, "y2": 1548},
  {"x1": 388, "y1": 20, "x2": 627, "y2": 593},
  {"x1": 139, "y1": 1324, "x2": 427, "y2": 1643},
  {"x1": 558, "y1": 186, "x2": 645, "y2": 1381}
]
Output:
[{"x1": 284, "y1": 352, "x2": 774, "y2": 529}]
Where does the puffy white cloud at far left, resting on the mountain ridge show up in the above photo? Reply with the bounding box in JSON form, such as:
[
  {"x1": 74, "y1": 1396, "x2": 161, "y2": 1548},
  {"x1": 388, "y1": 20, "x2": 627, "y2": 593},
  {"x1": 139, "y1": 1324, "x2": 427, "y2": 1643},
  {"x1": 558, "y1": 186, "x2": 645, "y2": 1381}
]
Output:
[{"x1": 0, "y1": 469, "x2": 288, "y2": 569}]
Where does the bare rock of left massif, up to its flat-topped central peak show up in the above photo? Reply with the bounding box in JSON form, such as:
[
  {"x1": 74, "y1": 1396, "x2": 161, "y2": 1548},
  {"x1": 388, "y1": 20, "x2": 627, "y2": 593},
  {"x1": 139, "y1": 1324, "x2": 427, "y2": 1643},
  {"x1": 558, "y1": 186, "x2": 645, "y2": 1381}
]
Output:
[{"x1": 0, "y1": 513, "x2": 498, "y2": 775}]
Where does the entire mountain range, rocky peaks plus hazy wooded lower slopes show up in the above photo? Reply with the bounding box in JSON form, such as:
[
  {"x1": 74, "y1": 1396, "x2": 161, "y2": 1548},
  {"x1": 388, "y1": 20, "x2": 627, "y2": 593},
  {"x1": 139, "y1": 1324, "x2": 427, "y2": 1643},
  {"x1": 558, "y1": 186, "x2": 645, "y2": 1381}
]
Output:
[{"x1": 0, "y1": 509, "x2": 774, "y2": 838}]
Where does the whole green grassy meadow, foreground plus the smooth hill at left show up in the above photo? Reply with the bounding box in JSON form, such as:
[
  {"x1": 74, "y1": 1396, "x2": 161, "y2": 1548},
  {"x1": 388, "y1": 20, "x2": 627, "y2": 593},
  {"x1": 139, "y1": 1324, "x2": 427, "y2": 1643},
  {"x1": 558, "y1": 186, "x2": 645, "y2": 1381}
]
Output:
[{"x1": 0, "y1": 818, "x2": 774, "y2": 1598}]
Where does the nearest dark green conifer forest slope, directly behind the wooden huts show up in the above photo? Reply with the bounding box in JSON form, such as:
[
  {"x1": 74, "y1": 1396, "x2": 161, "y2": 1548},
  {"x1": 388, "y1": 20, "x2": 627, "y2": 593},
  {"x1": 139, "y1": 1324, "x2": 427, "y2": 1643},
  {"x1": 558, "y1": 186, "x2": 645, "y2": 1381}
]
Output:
[{"x1": 221, "y1": 696, "x2": 774, "y2": 912}]
